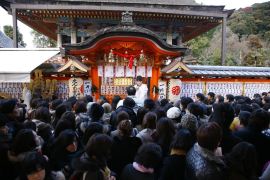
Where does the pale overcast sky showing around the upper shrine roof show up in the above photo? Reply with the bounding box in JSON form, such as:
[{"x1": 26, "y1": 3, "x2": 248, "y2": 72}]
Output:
[{"x1": 0, "y1": 0, "x2": 269, "y2": 48}]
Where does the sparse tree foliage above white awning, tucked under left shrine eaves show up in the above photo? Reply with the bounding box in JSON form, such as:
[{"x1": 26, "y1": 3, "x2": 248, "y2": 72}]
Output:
[{"x1": 31, "y1": 30, "x2": 56, "y2": 48}]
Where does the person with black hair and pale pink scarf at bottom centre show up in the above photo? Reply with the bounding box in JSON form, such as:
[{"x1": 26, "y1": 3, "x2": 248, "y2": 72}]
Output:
[{"x1": 120, "y1": 143, "x2": 162, "y2": 180}]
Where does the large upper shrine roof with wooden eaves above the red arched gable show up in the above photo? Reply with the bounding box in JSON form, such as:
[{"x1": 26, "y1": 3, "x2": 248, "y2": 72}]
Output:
[{"x1": 0, "y1": 0, "x2": 233, "y2": 42}]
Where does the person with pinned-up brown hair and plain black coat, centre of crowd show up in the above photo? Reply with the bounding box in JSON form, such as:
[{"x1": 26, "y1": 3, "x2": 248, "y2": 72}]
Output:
[{"x1": 109, "y1": 120, "x2": 142, "y2": 175}]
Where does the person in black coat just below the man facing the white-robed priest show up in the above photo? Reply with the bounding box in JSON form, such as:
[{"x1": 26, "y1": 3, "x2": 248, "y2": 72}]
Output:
[{"x1": 110, "y1": 97, "x2": 137, "y2": 129}]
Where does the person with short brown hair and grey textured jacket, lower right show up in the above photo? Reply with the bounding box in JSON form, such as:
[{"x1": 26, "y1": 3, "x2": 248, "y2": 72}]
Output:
[{"x1": 186, "y1": 122, "x2": 226, "y2": 180}]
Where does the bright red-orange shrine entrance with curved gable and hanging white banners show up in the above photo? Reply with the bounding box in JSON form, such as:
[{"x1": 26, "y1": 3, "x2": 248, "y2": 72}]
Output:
[{"x1": 64, "y1": 24, "x2": 186, "y2": 100}]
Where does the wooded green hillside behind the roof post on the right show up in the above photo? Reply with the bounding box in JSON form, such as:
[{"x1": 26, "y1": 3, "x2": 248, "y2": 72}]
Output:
[{"x1": 187, "y1": 2, "x2": 270, "y2": 66}]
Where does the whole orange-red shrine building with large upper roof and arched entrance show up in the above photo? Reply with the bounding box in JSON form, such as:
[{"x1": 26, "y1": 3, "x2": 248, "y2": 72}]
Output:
[{"x1": 0, "y1": 0, "x2": 269, "y2": 99}]
